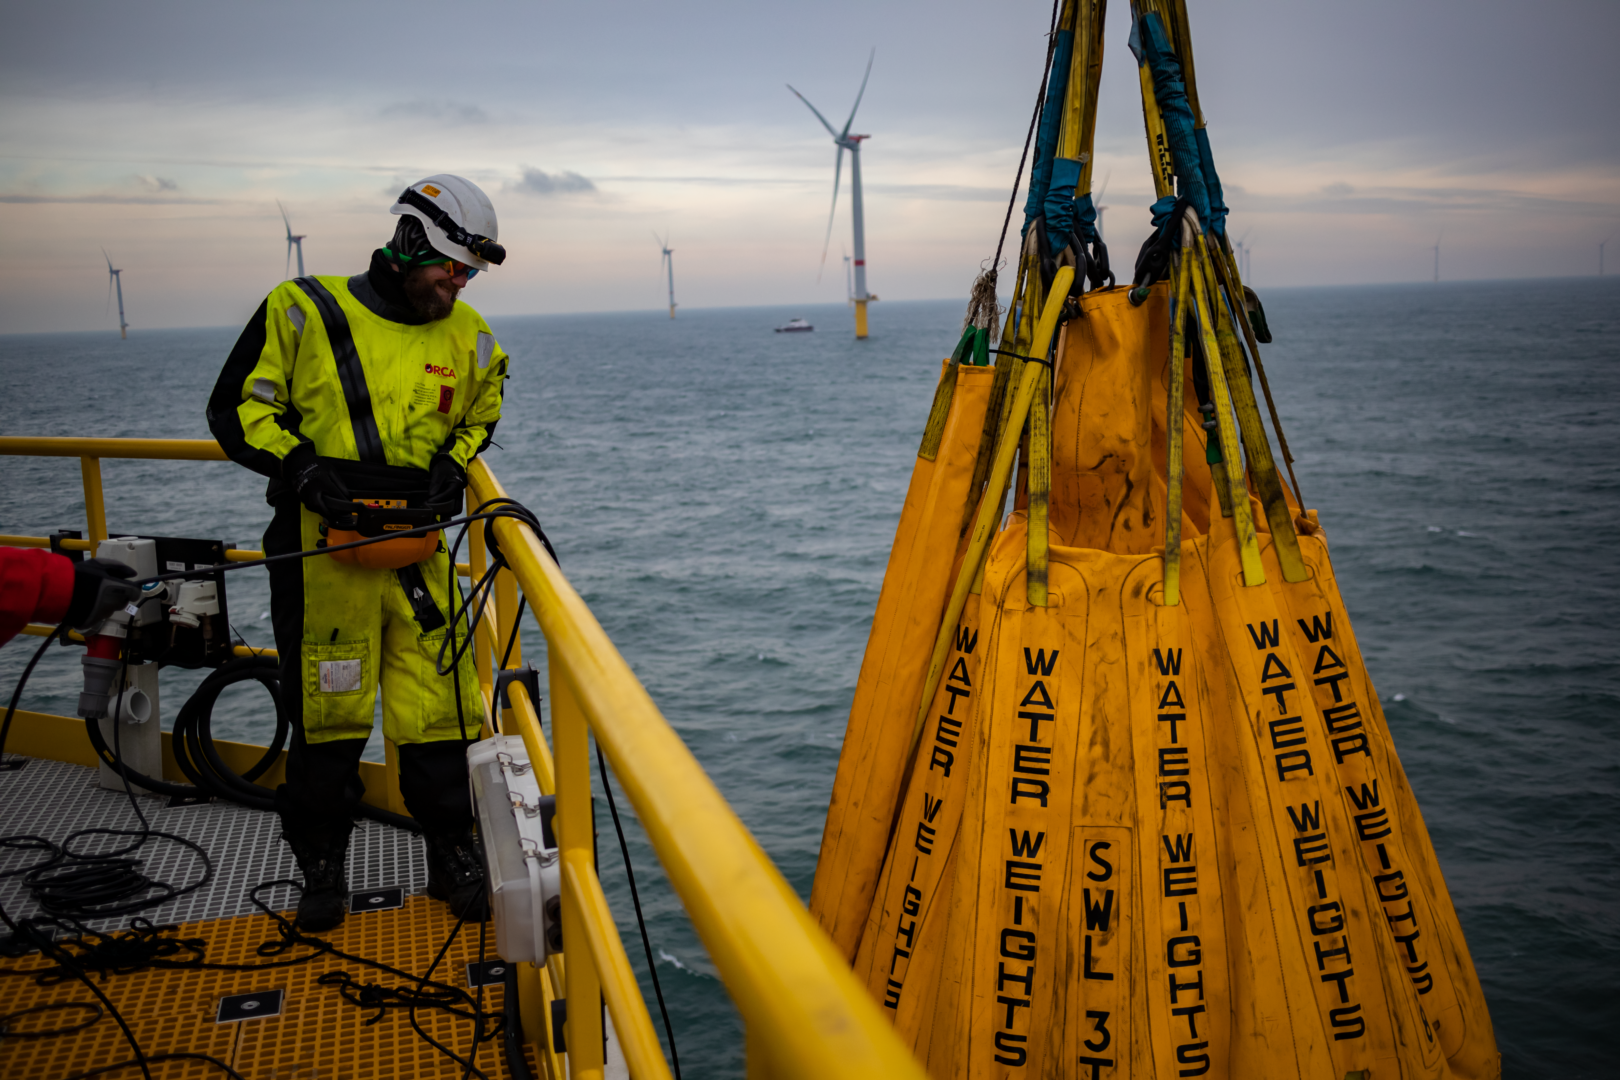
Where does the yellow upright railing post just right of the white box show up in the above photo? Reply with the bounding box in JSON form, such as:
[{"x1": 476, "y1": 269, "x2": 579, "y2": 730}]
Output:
[{"x1": 549, "y1": 661, "x2": 604, "y2": 1080}]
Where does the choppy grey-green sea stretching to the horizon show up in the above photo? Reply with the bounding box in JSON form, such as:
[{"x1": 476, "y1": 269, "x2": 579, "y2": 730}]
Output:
[{"x1": 0, "y1": 277, "x2": 1620, "y2": 1080}]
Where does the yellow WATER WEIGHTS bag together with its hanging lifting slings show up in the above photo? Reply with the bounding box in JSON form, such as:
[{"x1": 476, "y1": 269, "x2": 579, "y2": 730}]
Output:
[{"x1": 812, "y1": 0, "x2": 1500, "y2": 1080}]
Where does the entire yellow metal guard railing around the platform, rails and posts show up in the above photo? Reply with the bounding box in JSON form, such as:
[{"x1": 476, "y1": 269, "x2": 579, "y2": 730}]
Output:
[{"x1": 0, "y1": 436, "x2": 925, "y2": 1080}]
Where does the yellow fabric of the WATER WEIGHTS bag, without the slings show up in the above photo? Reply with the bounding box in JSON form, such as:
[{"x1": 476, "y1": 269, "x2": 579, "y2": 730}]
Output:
[{"x1": 816, "y1": 285, "x2": 1499, "y2": 1078}]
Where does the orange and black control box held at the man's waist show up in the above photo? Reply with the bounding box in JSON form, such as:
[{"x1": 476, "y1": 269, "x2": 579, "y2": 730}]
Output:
[{"x1": 319, "y1": 458, "x2": 446, "y2": 570}]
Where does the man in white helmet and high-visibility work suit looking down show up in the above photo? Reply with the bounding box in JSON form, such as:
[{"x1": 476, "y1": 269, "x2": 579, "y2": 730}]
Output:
[{"x1": 207, "y1": 175, "x2": 507, "y2": 931}]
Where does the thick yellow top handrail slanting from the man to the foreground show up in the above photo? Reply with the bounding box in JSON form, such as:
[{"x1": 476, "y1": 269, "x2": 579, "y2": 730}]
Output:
[{"x1": 468, "y1": 460, "x2": 923, "y2": 1080}]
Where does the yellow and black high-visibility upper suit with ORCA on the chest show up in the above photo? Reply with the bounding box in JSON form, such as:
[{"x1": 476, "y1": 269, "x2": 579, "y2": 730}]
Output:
[{"x1": 209, "y1": 274, "x2": 509, "y2": 497}]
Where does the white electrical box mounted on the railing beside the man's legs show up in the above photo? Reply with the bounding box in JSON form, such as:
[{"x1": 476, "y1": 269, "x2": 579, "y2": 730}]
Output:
[{"x1": 467, "y1": 735, "x2": 562, "y2": 963}]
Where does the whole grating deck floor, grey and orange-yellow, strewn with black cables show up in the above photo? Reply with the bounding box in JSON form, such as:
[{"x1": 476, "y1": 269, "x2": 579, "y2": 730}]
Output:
[{"x1": 0, "y1": 759, "x2": 541, "y2": 1080}]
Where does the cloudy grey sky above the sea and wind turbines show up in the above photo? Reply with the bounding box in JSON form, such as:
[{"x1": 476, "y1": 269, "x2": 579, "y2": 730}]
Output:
[{"x1": 0, "y1": 0, "x2": 1620, "y2": 332}]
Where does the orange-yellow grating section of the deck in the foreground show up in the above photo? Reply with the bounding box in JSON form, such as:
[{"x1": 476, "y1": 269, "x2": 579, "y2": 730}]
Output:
[{"x1": 0, "y1": 895, "x2": 541, "y2": 1080}]
